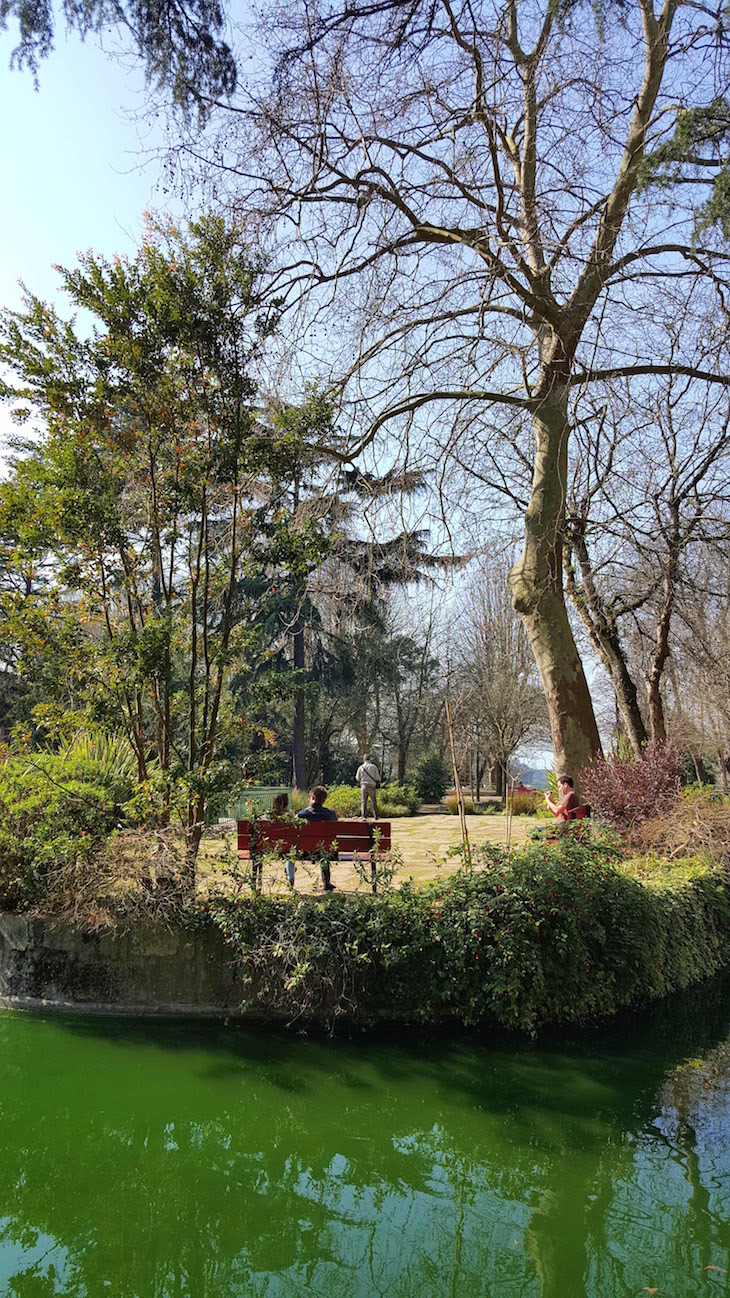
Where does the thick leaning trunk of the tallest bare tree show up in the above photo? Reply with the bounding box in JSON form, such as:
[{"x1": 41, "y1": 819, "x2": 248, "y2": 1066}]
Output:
[{"x1": 509, "y1": 384, "x2": 601, "y2": 787}]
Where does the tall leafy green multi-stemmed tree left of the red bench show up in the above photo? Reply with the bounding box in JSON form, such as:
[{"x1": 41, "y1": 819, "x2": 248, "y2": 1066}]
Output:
[{"x1": 0, "y1": 217, "x2": 322, "y2": 871}]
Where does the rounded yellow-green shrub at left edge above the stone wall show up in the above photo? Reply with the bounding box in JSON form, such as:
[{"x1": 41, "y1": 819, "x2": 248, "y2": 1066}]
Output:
[{"x1": 0, "y1": 753, "x2": 132, "y2": 910}]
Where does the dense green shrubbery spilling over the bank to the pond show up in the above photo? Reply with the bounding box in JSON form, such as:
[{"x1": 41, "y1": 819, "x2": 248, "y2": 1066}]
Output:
[{"x1": 213, "y1": 826, "x2": 730, "y2": 1031}]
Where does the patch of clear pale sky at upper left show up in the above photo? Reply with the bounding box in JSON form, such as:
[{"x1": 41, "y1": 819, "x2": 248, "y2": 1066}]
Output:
[{"x1": 0, "y1": 31, "x2": 177, "y2": 463}]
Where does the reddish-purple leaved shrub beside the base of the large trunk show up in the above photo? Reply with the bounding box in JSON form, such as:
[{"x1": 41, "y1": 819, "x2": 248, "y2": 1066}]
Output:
[{"x1": 581, "y1": 742, "x2": 682, "y2": 829}]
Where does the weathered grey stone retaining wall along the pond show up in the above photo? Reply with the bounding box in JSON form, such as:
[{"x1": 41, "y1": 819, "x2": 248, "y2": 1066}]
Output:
[{"x1": 0, "y1": 914, "x2": 240, "y2": 1018}]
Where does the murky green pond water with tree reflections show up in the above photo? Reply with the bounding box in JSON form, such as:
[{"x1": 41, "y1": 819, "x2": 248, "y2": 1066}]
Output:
[{"x1": 0, "y1": 984, "x2": 730, "y2": 1298}]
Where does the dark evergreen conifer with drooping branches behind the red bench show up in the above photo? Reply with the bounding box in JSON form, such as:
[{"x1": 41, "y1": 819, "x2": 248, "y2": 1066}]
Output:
[{"x1": 236, "y1": 399, "x2": 453, "y2": 788}]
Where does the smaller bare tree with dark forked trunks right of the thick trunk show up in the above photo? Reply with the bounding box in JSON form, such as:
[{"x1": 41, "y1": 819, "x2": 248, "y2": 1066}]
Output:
[{"x1": 565, "y1": 360, "x2": 730, "y2": 753}]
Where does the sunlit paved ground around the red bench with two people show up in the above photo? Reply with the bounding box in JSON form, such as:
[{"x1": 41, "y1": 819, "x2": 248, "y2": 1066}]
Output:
[{"x1": 200, "y1": 814, "x2": 535, "y2": 892}]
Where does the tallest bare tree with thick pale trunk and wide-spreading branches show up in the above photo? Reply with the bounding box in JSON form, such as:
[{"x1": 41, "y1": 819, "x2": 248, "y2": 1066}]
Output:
[{"x1": 172, "y1": 0, "x2": 729, "y2": 770}]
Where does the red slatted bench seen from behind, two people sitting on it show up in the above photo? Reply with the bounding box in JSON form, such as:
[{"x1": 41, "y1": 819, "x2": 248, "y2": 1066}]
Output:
[{"x1": 238, "y1": 819, "x2": 391, "y2": 892}]
